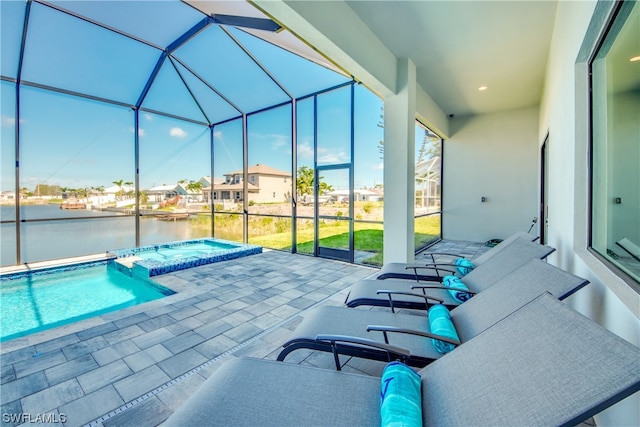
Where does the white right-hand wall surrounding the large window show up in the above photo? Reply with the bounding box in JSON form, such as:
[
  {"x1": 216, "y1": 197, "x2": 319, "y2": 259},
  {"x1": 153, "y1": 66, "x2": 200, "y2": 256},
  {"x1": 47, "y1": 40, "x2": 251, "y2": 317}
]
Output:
[{"x1": 538, "y1": 1, "x2": 640, "y2": 427}]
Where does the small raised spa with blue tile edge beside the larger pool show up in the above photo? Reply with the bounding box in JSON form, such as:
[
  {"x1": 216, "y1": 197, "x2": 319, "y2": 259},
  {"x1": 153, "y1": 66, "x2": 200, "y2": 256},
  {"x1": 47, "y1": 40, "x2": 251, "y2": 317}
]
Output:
[{"x1": 110, "y1": 238, "x2": 262, "y2": 278}]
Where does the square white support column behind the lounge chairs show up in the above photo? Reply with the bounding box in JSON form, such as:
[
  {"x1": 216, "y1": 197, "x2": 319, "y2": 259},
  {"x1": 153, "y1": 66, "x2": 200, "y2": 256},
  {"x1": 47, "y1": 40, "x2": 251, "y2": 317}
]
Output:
[{"x1": 384, "y1": 58, "x2": 417, "y2": 263}]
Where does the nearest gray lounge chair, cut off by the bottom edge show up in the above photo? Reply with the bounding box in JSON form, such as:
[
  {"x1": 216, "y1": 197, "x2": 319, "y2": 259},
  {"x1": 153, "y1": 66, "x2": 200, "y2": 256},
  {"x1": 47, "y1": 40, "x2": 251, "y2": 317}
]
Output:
[{"x1": 165, "y1": 295, "x2": 640, "y2": 427}]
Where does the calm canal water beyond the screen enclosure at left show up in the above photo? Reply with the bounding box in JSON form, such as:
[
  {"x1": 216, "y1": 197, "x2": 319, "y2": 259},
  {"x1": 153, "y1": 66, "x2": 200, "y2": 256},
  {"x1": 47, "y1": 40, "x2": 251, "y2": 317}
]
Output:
[{"x1": 0, "y1": 204, "x2": 210, "y2": 266}]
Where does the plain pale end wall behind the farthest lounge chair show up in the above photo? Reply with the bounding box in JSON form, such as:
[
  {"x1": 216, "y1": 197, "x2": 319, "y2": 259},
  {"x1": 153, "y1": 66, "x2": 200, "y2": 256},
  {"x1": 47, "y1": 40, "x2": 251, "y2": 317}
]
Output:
[{"x1": 443, "y1": 108, "x2": 539, "y2": 242}]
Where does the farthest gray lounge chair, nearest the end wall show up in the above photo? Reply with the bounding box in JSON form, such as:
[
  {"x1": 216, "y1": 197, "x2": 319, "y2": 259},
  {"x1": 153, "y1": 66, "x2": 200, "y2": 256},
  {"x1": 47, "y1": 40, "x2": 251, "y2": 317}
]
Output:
[{"x1": 375, "y1": 231, "x2": 538, "y2": 281}]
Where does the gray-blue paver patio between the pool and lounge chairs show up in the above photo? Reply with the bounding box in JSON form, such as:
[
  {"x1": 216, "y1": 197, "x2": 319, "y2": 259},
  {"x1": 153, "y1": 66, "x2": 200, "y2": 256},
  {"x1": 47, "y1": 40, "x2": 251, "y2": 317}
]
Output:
[{"x1": 0, "y1": 242, "x2": 487, "y2": 426}]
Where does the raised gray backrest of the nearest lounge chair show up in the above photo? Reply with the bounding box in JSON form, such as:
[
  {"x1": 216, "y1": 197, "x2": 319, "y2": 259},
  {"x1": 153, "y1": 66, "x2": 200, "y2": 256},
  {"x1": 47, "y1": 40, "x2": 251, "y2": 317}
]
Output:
[{"x1": 420, "y1": 294, "x2": 640, "y2": 426}]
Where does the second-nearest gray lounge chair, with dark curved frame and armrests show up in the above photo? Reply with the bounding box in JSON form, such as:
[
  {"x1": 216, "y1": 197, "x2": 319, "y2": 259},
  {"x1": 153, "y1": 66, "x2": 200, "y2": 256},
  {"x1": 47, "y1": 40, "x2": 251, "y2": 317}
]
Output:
[{"x1": 278, "y1": 259, "x2": 589, "y2": 370}]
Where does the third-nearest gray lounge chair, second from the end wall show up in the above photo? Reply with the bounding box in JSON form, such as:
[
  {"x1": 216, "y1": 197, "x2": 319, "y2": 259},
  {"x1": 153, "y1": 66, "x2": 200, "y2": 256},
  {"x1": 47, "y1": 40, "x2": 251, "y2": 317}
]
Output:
[{"x1": 345, "y1": 239, "x2": 555, "y2": 310}]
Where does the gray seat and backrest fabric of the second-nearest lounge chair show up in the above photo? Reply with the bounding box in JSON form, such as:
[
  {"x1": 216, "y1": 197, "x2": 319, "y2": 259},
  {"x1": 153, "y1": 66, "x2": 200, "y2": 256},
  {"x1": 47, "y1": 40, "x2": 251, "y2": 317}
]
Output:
[{"x1": 283, "y1": 259, "x2": 589, "y2": 366}]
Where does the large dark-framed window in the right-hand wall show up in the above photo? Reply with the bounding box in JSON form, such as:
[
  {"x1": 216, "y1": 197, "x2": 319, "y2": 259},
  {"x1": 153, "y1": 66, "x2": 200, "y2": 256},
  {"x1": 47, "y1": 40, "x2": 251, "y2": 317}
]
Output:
[{"x1": 589, "y1": 2, "x2": 640, "y2": 288}]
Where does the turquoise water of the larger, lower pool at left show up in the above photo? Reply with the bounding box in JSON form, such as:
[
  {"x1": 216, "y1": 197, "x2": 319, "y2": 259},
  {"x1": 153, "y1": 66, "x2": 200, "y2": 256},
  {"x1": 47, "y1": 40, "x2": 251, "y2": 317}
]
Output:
[{"x1": 0, "y1": 261, "x2": 174, "y2": 341}]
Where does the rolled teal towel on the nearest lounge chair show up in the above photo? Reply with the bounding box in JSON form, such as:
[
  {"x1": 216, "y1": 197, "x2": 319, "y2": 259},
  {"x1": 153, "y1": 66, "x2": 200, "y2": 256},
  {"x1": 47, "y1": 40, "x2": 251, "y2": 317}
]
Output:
[{"x1": 380, "y1": 362, "x2": 422, "y2": 427}]
